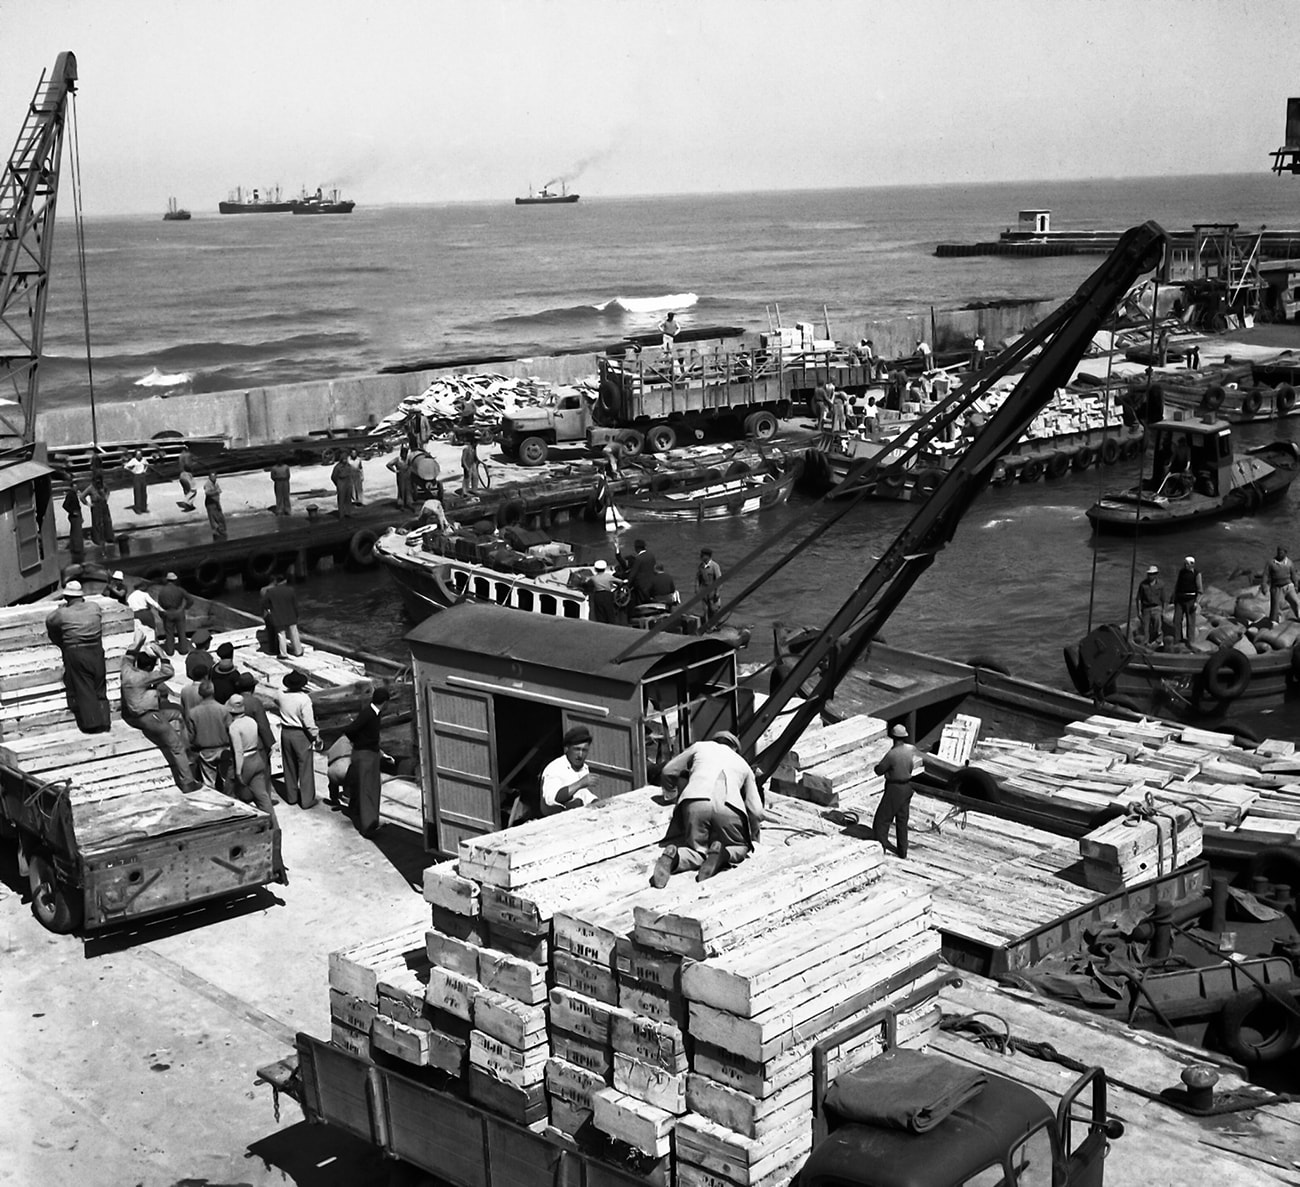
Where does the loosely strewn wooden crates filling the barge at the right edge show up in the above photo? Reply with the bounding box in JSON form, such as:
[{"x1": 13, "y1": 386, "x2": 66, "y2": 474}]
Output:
[{"x1": 927, "y1": 714, "x2": 1300, "y2": 844}]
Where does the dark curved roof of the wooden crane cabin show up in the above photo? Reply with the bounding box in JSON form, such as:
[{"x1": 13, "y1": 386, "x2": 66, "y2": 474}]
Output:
[{"x1": 407, "y1": 602, "x2": 733, "y2": 684}]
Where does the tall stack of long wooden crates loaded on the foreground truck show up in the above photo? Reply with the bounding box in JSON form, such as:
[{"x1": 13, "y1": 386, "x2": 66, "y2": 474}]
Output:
[{"x1": 330, "y1": 788, "x2": 939, "y2": 1187}]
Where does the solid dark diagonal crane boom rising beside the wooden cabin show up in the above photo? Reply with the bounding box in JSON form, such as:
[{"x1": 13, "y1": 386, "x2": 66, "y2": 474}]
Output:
[{"x1": 738, "y1": 222, "x2": 1167, "y2": 779}]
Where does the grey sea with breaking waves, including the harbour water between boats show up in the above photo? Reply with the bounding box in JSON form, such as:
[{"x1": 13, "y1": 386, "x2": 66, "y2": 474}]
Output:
[{"x1": 42, "y1": 173, "x2": 1300, "y2": 737}]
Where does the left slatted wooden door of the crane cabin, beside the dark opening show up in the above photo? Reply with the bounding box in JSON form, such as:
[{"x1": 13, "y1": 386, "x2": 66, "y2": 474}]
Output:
[{"x1": 424, "y1": 685, "x2": 501, "y2": 853}]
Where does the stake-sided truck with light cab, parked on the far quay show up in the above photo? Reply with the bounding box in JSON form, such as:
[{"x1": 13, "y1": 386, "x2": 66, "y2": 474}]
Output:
[{"x1": 498, "y1": 326, "x2": 871, "y2": 465}]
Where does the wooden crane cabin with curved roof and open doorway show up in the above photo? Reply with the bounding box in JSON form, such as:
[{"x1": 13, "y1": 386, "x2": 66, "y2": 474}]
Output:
[{"x1": 407, "y1": 603, "x2": 738, "y2": 854}]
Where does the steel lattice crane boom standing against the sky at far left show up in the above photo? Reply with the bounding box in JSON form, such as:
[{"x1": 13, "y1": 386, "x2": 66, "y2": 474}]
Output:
[{"x1": 0, "y1": 51, "x2": 77, "y2": 449}]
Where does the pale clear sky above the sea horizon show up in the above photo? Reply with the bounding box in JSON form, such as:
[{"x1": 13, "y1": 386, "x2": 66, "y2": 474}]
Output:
[{"x1": 0, "y1": 0, "x2": 1300, "y2": 216}]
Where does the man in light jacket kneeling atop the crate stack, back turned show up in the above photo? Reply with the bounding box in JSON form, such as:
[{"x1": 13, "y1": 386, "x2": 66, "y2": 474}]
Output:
[{"x1": 650, "y1": 729, "x2": 763, "y2": 888}]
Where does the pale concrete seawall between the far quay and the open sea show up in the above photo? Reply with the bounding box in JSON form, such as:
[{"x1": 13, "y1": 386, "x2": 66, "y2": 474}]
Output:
[{"x1": 36, "y1": 302, "x2": 1058, "y2": 449}]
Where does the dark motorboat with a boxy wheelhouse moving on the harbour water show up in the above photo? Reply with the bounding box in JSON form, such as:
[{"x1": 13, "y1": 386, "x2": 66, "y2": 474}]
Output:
[{"x1": 1087, "y1": 413, "x2": 1300, "y2": 532}]
